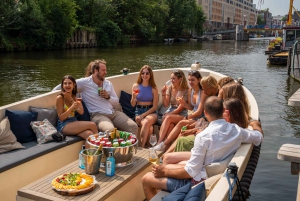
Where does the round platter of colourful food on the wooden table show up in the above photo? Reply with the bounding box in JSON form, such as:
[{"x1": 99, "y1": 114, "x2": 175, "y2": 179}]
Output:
[{"x1": 51, "y1": 173, "x2": 97, "y2": 196}]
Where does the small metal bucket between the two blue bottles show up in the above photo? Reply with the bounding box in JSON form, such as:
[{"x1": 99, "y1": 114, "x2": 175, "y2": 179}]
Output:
[{"x1": 82, "y1": 149, "x2": 103, "y2": 174}]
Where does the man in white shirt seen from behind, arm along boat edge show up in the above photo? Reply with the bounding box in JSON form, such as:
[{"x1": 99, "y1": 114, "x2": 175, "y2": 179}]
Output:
[{"x1": 142, "y1": 96, "x2": 263, "y2": 200}]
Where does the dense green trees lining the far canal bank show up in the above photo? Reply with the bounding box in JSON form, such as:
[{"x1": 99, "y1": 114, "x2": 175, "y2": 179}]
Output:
[{"x1": 0, "y1": 0, "x2": 205, "y2": 50}]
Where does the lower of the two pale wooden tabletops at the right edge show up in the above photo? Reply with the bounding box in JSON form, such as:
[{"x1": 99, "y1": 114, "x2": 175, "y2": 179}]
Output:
[{"x1": 277, "y1": 144, "x2": 300, "y2": 201}]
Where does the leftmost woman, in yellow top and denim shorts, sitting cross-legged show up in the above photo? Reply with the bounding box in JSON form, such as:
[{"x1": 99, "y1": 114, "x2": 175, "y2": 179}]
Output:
[{"x1": 56, "y1": 75, "x2": 98, "y2": 139}]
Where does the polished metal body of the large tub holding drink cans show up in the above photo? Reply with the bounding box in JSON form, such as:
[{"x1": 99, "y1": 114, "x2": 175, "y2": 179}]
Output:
[{"x1": 86, "y1": 134, "x2": 138, "y2": 167}]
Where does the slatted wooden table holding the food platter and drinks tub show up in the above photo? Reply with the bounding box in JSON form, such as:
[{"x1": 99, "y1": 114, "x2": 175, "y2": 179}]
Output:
[{"x1": 16, "y1": 148, "x2": 156, "y2": 201}]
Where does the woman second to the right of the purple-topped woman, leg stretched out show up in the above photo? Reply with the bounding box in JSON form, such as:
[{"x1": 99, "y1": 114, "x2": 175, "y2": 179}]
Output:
[{"x1": 153, "y1": 70, "x2": 207, "y2": 151}]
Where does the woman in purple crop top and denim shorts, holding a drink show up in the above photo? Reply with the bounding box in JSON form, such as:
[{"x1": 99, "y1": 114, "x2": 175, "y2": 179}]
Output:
[{"x1": 130, "y1": 65, "x2": 158, "y2": 147}]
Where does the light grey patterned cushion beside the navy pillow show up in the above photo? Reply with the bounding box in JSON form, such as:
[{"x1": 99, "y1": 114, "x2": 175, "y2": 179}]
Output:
[{"x1": 30, "y1": 119, "x2": 57, "y2": 144}]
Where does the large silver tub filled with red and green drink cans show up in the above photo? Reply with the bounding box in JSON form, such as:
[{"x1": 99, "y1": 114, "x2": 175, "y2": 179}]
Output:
[{"x1": 86, "y1": 129, "x2": 138, "y2": 167}]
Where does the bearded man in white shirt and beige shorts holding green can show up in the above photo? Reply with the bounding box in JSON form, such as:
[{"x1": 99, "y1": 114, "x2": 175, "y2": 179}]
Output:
[{"x1": 76, "y1": 60, "x2": 138, "y2": 134}]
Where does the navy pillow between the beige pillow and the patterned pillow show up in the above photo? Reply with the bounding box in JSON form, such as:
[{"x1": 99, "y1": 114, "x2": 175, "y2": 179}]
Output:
[{"x1": 5, "y1": 110, "x2": 38, "y2": 143}]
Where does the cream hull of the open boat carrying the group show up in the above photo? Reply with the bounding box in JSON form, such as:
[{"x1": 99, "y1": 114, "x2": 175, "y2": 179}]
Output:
[{"x1": 0, "y1": 64, "x2": 260, "y2": 201}]
